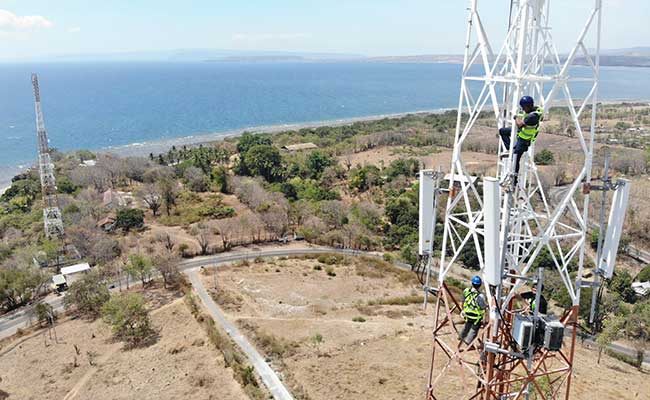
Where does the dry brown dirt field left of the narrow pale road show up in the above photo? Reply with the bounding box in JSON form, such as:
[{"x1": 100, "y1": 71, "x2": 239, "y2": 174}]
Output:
[{"x1": 0, "y1": 299, "x2": 247, "y2": 400}]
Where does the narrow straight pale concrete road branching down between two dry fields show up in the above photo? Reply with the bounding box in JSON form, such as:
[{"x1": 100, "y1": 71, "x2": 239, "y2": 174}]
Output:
[{"x1": 185, "y1": 269, "x2": 293, "y2": 400}]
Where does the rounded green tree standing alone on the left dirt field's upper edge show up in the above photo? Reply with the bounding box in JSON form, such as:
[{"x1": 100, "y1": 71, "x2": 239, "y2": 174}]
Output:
[{"x1": 102, "y1": 293, "x2": 156, "y2": 347}]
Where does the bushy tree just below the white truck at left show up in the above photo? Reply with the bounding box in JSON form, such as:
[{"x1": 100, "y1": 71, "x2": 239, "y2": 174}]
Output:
[{"x1": 63, "y1": 271, "x2": 110, "y2": 319}]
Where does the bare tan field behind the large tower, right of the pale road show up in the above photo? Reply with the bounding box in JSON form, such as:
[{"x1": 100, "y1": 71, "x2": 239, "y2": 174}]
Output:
[{"x1": 203, "y1": 259, "x2": 650, "y2": 400}]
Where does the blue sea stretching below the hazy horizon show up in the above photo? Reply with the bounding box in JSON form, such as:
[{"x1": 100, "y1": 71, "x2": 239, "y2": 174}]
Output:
[{"x1": 0, "y1": 62, "x2": 650, "y2": 187}]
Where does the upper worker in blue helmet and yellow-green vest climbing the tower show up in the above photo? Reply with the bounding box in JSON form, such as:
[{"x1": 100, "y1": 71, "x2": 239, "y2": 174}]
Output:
[{"x1": 499, "y1": 96, "x2": 544, "y2": 185}]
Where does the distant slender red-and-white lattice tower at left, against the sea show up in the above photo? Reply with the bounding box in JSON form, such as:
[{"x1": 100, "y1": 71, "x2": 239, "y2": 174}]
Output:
[{"x1": 32, "y1": 74, "x2": 64, "y2": 238}]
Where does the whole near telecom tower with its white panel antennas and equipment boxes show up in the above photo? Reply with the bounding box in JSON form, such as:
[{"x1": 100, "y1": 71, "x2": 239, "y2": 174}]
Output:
[{"x1": 420, "y1": 0, "x2": 629, "y2": 400}]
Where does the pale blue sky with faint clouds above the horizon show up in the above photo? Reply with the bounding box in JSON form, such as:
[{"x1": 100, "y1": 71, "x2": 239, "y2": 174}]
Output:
[{"x1": 0, "y1": 0, "x2": 650, "y2": 60}]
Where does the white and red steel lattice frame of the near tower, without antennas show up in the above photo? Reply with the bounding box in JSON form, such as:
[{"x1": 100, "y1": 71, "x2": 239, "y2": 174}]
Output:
[{"x1": 427, "y1": 0, "x2": 602, "y2": 400}]
